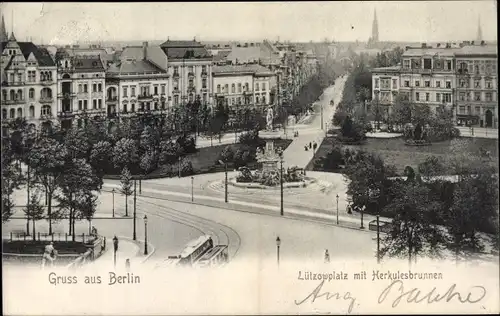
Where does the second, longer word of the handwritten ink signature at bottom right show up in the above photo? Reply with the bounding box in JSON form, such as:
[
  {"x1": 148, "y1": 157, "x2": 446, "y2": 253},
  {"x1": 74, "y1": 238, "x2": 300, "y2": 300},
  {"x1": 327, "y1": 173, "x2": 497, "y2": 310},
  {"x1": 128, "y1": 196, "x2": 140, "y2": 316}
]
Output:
[{"x1": 378, "y1": 280, "x2": 486, "y2": 308}]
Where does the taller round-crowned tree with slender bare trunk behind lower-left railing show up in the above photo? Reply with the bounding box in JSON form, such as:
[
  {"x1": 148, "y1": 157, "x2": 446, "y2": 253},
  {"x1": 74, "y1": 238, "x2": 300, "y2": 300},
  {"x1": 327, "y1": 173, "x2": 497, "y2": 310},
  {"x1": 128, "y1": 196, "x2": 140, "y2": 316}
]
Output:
[{"x1": 28, "y1": 138, "x2": 68, "y2": 234}]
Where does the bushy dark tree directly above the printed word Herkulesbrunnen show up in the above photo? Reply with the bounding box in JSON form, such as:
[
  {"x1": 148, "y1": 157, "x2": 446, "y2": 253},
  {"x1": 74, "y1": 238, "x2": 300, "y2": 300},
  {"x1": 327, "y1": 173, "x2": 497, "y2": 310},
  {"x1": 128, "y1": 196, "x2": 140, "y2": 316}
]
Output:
[{"x1": 381, "y1": 182, "x2": 443, "y2": 265}]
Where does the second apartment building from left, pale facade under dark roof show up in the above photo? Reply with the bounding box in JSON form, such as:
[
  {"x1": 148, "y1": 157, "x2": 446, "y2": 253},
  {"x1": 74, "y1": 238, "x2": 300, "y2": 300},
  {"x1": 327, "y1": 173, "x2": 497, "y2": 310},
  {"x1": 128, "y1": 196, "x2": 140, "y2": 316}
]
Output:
[{"x1": 56, "y1": 49, "x2": 106, "y2": 128}]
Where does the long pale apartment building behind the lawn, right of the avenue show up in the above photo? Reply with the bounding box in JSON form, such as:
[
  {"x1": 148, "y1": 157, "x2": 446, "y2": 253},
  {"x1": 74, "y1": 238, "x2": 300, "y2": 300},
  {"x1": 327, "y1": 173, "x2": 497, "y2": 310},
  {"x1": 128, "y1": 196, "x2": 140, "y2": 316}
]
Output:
[{"x1": 372, "y1": 42, "x2": 498, "y2": 128}]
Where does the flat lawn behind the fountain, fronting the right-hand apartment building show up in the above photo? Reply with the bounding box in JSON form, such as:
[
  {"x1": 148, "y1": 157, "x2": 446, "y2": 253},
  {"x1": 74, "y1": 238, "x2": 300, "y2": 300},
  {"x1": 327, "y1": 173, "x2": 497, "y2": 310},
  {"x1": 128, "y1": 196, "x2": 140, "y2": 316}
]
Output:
[{"x1": 307, "y1": 137, "x2": 498, "y2": 174}]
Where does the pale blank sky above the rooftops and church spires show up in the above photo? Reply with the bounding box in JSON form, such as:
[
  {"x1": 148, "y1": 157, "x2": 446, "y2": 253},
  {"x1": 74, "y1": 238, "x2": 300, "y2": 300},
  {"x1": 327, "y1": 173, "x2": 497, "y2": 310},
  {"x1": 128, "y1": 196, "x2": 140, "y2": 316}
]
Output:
[{"x1": 0, "y1": 0, "x2": 497, "y2": 44}]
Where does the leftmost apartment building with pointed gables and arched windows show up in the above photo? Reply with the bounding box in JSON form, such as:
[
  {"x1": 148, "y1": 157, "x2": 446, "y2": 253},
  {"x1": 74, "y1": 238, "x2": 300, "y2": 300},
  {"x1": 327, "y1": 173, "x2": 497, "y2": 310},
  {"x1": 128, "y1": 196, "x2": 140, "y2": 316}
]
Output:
[{"x1": 0, "y1": 29, "x2": 57, "y2": 133}]
